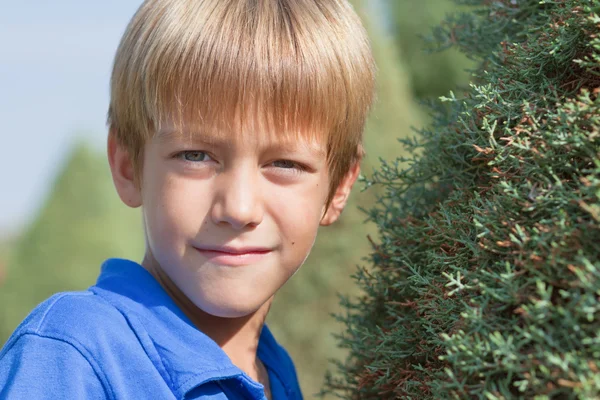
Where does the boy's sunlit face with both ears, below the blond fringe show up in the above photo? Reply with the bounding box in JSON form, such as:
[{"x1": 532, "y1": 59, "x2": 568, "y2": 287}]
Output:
[{"x1": 109, "y1": 125, "x2": 358, "y2": 317}]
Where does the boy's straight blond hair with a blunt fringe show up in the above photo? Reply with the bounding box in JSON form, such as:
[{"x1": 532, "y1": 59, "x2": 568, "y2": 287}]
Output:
[{"x1": 108, "y1": 0, "x2": 375, "y2": 205}]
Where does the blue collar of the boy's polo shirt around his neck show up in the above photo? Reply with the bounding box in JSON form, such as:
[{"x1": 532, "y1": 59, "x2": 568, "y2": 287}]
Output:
[{"x1": 90, "y1": 259, "x2": 268, "y2": 398}]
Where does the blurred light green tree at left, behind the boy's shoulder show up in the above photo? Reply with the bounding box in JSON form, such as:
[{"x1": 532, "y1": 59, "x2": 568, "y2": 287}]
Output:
[{"x1": 0, "y1": 145, "x2": 143, "y2": 343}]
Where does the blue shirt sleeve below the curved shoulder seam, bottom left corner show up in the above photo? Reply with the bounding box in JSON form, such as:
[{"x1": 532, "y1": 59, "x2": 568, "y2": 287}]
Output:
[{"x1": 0, "y1": 334, "x2": 108, "y2": 400}]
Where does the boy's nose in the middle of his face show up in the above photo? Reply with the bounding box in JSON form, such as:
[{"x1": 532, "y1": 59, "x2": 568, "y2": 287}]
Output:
[{"x1": 211, "y1": 166, "x2": 264, "y2": 230}]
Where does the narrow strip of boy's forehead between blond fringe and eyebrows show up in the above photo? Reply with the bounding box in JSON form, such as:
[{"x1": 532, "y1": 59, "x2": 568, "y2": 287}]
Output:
[{"x1": 154, "y1": 125, "x2": 327, "y2": 157}]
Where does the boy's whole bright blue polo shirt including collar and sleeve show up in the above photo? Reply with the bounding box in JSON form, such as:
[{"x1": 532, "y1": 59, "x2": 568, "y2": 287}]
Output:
[{"x1": 0, "y1": 259, "x2": 302, "y2": 400}]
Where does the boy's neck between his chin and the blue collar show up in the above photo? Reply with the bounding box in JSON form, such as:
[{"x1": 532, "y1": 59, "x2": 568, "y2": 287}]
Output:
[{"x1": 142, "y1": 254, "x2": 273, "y2": 383}]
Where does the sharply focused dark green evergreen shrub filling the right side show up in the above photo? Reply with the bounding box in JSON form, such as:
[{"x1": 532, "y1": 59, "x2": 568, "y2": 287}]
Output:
[{"x1": 326, "y1": 0, "x2": 600, "y2": 400}]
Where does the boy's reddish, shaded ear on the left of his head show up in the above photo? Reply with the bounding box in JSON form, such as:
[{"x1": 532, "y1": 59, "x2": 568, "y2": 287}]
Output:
[{"x1": 107, "y1": 128, "x2": 142, "y2": 208}]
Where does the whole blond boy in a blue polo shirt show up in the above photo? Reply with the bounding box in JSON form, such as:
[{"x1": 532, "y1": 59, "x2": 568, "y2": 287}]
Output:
[{"x1": 0, "y1": 0, "x2": 374, "y2": 400}]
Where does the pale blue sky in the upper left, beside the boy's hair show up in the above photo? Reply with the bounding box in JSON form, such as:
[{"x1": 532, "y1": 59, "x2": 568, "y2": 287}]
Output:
[{"x1": 0, "y1": 0, "x2": 141, "y2": 235}]
